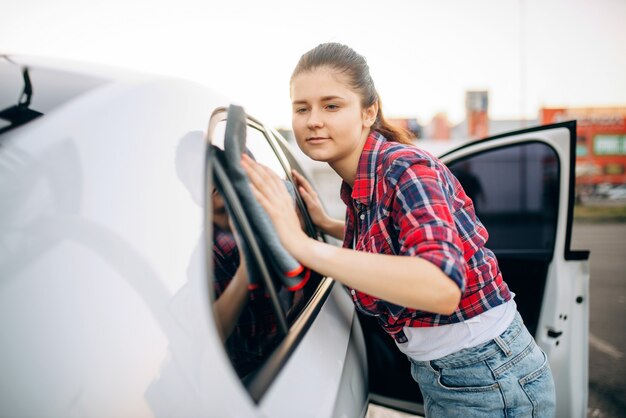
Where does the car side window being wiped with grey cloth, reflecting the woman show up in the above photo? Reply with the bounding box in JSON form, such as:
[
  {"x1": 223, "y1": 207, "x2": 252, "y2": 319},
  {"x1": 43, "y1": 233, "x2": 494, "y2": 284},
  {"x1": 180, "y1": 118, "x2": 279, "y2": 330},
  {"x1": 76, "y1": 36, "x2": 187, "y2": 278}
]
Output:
[{"x1": 210, "y1": 112, "x2": 321, "y2": 382}]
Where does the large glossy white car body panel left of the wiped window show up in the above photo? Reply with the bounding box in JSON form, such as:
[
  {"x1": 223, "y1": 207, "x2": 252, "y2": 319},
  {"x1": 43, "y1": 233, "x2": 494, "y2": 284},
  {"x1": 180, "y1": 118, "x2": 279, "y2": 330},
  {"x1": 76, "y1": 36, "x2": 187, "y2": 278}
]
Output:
[{"x1": 0, "y1": 62, "x2": 254, "y2": 417}]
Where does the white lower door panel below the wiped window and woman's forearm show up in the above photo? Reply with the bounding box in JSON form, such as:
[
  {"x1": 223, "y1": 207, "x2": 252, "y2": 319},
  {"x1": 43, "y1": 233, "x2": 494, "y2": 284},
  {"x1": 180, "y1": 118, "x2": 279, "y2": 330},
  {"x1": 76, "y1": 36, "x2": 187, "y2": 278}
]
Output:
[{"x1": 261, "y1": 283, "x2": 367, "y2": 418}]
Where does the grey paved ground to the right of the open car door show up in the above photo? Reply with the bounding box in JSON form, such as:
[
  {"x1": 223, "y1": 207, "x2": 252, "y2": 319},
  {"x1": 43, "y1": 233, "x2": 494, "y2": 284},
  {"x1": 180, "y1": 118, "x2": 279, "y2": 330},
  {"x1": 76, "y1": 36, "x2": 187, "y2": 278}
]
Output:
[{"x1": 572, "y1": 223, "x2": 626, "y2": 418}]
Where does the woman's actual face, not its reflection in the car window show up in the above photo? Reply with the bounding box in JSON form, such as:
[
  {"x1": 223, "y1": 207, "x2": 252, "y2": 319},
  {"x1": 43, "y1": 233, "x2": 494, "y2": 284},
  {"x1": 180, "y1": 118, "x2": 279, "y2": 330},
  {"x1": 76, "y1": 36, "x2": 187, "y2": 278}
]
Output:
[{"x1": 291, "y1": 67, "x2": 378, "y2": 165}]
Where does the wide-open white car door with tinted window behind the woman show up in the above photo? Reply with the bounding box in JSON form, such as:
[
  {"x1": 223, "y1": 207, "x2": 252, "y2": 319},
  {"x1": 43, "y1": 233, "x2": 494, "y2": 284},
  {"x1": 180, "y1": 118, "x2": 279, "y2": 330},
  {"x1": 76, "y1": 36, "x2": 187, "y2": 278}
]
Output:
[{"x1": 361, "y1": 122, "x2": 589, "y2": 417}]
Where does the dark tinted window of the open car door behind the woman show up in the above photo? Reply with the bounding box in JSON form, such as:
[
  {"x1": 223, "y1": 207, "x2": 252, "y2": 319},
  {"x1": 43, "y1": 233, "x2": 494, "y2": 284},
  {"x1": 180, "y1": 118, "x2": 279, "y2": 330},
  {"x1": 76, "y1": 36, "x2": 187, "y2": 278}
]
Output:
[{"x1": 449, "y1": 142, "x2": 559, "y2": 251}]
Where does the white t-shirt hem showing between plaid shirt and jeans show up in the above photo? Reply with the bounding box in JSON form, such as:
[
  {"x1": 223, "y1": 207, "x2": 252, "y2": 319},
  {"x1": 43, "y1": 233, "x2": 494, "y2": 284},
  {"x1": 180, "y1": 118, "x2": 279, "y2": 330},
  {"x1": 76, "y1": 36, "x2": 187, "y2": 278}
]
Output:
[{"x1": 396, "y1": 293, "x2": 517, "y2": 361}]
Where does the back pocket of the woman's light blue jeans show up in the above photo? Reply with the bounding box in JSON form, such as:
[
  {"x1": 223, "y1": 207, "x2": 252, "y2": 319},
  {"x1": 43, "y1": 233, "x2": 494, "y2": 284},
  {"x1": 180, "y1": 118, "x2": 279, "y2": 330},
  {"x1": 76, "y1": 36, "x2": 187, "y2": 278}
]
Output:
[{"x1": 519, "y1": 347, "x2": 556, "y2": 417}]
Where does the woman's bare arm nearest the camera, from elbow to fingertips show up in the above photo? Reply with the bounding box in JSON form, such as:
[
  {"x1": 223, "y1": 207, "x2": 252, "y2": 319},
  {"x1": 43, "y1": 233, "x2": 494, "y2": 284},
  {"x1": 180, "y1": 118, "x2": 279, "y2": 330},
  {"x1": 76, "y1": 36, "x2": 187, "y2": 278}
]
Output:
[{"x1": 242, "y1": 155, "x2": 461, "y2": 314}]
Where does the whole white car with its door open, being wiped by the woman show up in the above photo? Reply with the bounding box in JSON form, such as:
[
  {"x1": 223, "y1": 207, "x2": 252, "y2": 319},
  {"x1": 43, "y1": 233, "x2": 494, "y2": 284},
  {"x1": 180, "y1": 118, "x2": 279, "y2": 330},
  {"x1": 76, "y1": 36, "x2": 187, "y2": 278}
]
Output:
[{"x1": 0, "y1": 57, "x2": 589, "y2": 417}]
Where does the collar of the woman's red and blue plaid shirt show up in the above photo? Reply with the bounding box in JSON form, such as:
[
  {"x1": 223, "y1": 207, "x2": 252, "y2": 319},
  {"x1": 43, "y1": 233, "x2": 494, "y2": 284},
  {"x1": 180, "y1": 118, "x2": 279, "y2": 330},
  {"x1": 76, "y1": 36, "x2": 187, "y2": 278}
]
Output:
[{"x1": 341, "y1": 131, "x2": 387, "y2": 206}]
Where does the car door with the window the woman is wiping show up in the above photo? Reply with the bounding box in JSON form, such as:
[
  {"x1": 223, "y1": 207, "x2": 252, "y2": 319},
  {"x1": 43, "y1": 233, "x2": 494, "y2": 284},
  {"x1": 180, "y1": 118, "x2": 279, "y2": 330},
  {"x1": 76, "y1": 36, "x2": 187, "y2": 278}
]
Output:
[{"x1": 206, "y1": 106, "x2": 367, "y2": 417}]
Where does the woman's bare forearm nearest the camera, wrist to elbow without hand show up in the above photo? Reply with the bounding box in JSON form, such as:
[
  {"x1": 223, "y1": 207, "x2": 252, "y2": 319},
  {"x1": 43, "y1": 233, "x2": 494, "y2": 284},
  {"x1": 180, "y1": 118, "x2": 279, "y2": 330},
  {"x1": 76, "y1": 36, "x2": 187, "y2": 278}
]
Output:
[{"x1": 294, "y1": 239, "x2": 461, "y2": 315}]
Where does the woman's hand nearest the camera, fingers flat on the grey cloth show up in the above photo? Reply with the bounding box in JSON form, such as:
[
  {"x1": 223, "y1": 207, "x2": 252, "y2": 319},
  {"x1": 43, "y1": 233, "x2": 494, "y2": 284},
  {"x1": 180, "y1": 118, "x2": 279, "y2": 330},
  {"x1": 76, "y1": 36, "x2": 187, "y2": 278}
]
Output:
[{"x1": 241, "y1": 154, "x2": 307, "y2": 255}]
